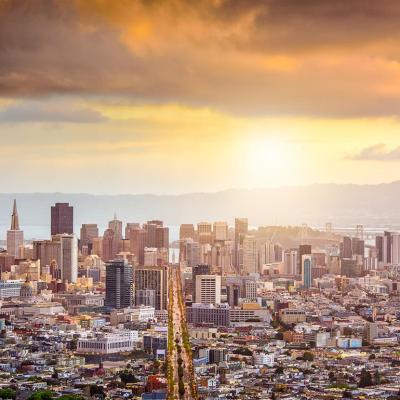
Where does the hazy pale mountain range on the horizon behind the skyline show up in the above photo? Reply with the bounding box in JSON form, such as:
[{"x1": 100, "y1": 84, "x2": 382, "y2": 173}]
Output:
[{"x1": 0, "y1": 181, "x2": 400, "y2": 231}]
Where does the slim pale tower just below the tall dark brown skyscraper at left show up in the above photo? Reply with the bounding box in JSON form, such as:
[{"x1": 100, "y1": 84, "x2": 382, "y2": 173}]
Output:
[{"x1": 57, "y1": 234, "x2": 78, "y2": 283}]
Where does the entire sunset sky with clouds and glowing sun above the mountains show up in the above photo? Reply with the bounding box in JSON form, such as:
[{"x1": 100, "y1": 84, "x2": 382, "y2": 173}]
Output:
[{"x1": 0, "y1": 0, "x2": 400, "y2": 194}]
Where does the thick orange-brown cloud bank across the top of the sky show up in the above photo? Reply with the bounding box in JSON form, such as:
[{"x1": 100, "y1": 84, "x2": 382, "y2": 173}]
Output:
[{"x1": 0, "y1": 0, "x2": 400, "y2": 118}]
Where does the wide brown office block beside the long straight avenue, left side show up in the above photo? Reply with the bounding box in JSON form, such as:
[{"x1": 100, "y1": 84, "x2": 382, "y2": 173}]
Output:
[{"x1": 134, "y1": 266, "x2": 168, "y2": 310}]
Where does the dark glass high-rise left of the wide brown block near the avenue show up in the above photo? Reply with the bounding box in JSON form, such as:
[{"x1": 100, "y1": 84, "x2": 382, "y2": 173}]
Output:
[{"x1": 104, "y1": 260, "x2": 133, "y2": 308}]
